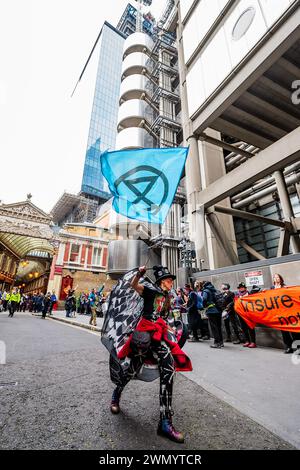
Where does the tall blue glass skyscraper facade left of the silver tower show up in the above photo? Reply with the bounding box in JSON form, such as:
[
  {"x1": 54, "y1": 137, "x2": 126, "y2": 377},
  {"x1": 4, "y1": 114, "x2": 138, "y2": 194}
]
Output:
[{"x1": 81, "y1": 22, "x2": 125, "y2": 199}]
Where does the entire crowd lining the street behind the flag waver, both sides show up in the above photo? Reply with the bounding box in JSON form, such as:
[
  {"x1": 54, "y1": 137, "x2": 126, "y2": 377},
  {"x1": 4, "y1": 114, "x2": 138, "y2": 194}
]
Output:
[{"x1": 0, "y1": 274, "x2": 300, "y2": 354}]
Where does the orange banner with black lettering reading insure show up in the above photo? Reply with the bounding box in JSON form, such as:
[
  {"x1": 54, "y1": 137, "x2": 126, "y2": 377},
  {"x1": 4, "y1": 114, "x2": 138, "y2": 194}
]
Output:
[{"x1": 234, "y1": 286, "x2": 300, "y2": 332}]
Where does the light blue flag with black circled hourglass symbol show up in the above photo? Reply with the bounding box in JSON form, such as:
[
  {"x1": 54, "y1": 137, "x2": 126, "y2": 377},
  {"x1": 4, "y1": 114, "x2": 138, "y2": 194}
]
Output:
[{"x1": 101, "y1": 147, "x2": 188, "y2": 224}]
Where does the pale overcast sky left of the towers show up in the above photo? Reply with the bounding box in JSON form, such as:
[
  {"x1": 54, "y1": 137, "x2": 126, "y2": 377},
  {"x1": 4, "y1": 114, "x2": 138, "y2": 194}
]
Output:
[{"x1": 0, "y1": 0, "x2": 165, "y2": 211}]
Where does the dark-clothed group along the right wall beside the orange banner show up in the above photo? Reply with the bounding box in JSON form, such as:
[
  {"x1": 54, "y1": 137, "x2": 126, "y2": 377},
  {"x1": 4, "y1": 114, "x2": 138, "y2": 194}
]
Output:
[{"x1": 174, "y1": 274, "x2": 300, "y2": 354}]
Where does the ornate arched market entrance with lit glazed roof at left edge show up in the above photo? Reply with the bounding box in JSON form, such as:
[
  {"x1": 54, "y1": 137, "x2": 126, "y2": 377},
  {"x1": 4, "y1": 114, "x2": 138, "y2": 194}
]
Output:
[{"x1": 0, "y1": 194, "x2": 57, "y2": 294}]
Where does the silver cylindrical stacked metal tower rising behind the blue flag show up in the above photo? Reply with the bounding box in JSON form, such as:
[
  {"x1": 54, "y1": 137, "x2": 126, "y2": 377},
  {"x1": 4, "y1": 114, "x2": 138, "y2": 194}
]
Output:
[{"x1": 97, "y1": 0, "x2": 186, "y2": 277}]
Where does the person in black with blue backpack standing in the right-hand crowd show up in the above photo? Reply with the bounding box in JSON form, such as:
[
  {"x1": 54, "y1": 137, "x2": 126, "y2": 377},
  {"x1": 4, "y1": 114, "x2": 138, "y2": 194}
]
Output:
[{"x1": 202, "y1": 281, "x2": 224, "y2": 349}]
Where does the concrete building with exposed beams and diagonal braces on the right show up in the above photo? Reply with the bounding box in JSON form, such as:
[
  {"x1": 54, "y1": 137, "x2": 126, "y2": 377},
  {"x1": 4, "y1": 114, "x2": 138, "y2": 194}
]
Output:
[{"x1": 175, "y1": 0, "x2": 300, "y2": 289}]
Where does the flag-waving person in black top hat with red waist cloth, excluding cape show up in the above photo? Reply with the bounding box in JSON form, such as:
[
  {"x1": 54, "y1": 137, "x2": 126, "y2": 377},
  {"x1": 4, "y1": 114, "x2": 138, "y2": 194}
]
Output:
[{"x1": 110, "y1": 266, "x2": 192, "y2": 443}]
